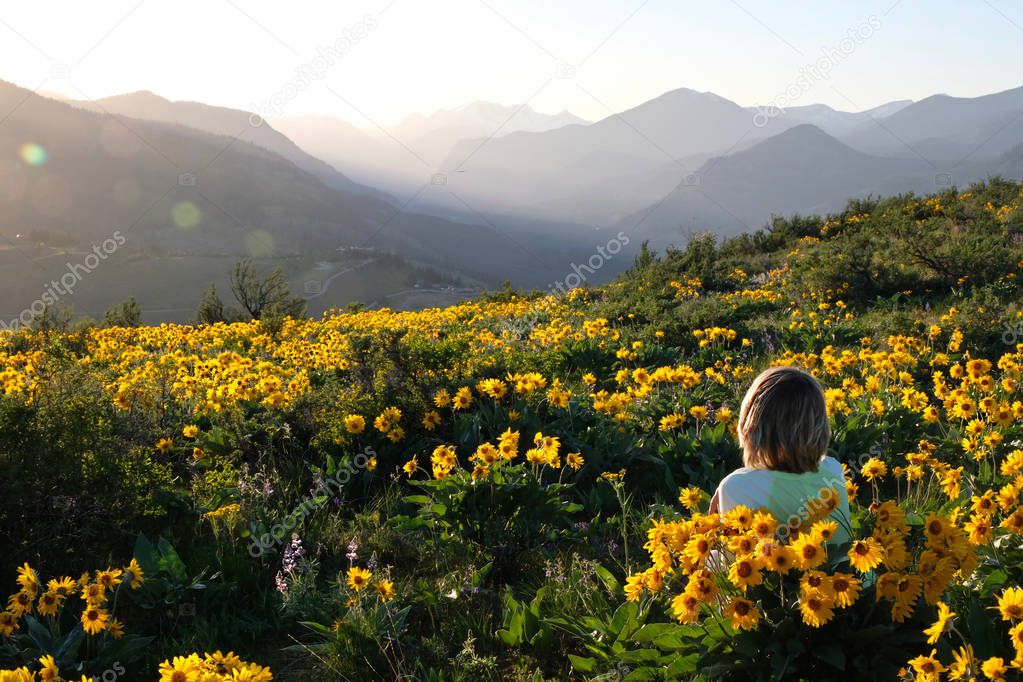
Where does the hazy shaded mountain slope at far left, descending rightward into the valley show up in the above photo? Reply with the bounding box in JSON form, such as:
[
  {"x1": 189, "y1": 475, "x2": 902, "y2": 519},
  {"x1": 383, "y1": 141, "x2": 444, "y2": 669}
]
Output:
[{"x1": 0, "y1": 83, "x2": 548, "y2": 281}]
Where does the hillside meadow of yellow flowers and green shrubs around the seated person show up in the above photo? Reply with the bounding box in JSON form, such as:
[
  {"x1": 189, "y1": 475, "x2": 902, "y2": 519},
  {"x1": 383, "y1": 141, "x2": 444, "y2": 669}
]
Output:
[{"x1": 0, "y1": 181, "x2": 1023, "y2": 682}]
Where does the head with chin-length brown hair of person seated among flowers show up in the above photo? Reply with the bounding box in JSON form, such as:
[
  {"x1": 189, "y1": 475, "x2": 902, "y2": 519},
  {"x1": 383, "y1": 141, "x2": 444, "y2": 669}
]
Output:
[{"x1": 739, "y1": 367, "x2": 831, "y2": 473}]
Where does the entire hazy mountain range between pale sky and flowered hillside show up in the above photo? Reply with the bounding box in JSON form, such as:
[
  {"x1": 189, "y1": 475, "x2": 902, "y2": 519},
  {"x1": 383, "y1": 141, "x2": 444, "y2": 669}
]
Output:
[{"x1": 0, "y1": 75, "x2": 1023, "y2": 323}]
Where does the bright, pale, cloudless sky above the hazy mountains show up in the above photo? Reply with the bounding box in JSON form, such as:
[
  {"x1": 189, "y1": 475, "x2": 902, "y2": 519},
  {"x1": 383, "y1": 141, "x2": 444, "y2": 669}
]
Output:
[{"x1": 0, "y1": 0, "x2": 1023, "y2": 126}]
